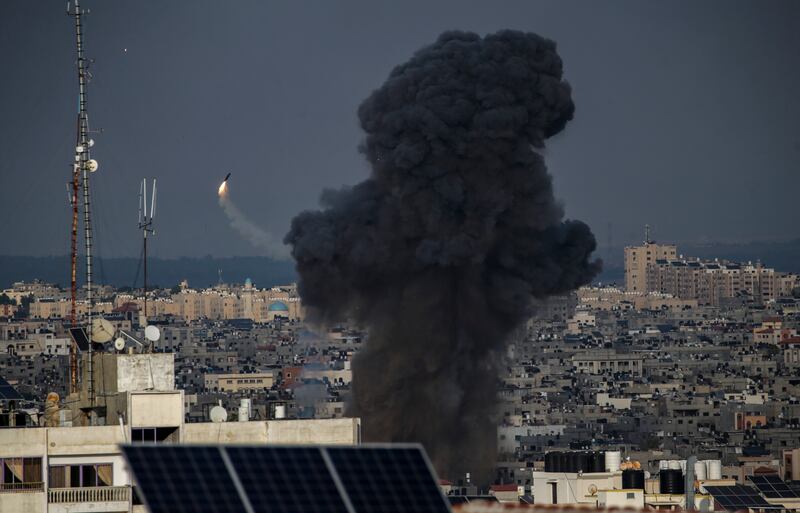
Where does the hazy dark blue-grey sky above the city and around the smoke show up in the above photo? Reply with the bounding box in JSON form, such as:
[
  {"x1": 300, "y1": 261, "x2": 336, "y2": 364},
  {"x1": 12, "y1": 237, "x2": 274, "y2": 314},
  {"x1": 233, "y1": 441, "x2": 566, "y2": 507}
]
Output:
[{"x1": 0, "y1": 0, "x2": 800, "y2": 257}]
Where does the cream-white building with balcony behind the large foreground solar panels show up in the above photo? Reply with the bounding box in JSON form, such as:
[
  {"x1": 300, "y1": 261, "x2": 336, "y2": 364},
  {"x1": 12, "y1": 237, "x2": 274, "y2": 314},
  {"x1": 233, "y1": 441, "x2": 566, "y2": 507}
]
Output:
[{"x1": 0, "y1": 354, "x2": 361, "y2": 513}]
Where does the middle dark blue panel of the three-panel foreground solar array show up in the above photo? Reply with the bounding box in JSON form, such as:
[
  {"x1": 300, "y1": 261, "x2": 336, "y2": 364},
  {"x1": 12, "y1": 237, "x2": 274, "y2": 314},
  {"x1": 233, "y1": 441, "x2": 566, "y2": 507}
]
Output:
[{"x1": 224, "y1": 446, "x2": 347, "y2": 513}]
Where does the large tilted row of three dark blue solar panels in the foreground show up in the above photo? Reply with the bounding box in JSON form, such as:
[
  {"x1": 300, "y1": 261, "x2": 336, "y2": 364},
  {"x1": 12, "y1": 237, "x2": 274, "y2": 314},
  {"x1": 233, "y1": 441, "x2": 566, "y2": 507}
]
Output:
[{"x1": 122, "y1": 444, "x2": 449, "y2": 513}]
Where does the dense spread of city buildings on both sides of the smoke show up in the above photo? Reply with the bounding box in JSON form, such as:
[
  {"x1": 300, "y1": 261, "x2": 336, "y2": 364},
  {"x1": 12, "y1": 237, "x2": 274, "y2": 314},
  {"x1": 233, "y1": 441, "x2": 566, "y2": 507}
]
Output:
[{"x1": 0, "y1": 241, "x2": 800, "y2": 511}]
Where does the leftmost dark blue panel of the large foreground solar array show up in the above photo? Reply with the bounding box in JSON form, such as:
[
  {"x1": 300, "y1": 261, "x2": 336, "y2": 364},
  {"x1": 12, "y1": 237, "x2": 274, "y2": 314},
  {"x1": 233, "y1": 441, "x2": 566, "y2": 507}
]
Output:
[{"x1": 122, "y1": 445, "x2": 246, "y2": 513}]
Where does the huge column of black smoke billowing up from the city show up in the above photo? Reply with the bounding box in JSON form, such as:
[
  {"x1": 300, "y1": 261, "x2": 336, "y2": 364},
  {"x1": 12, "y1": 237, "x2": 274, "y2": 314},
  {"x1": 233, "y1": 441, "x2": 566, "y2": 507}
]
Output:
[{"x1": 285, "y1": 31, "x2": 600, "y2": 483}]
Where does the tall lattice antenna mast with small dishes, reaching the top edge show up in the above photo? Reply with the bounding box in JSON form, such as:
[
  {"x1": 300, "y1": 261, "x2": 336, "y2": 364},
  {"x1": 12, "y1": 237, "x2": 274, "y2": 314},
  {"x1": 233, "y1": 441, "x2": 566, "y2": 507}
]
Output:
[{"x1": 67, "y1": 0, "x2": 98, "y2": 407}]
